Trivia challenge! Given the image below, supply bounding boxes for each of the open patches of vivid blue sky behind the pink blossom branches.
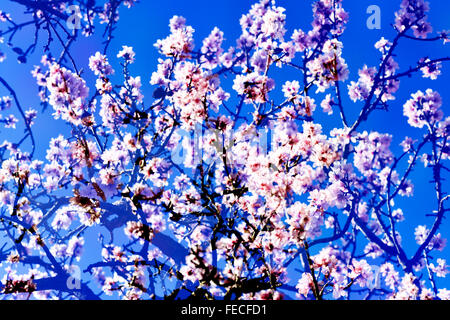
[0,0,450,298]
